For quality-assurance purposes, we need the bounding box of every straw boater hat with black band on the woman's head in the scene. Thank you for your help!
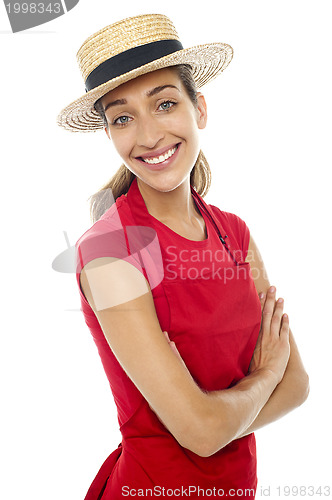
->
[57,14,233,132]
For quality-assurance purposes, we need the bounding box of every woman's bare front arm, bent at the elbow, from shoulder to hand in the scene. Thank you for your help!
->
[81,257,289,456]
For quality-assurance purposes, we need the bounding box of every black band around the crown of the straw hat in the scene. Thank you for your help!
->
[85,40,183,92]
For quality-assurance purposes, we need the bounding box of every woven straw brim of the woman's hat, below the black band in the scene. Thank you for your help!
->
[57,43,233,132]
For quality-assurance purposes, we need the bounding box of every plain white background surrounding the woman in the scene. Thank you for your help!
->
[0,0,332,500]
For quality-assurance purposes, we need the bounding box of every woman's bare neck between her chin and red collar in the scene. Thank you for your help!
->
[137,176,199,221]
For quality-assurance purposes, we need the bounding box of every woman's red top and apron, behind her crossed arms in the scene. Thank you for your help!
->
[76,179,261,500]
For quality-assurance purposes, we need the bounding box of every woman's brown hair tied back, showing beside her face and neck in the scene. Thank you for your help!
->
[89,64,211,223]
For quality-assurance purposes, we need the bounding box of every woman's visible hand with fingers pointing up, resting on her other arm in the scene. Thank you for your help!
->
[249,287,290,384]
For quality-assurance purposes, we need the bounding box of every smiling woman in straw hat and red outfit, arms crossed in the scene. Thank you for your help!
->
[58,15,308,500]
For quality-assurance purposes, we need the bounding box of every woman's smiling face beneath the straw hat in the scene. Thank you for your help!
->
[102,68,206,192]
